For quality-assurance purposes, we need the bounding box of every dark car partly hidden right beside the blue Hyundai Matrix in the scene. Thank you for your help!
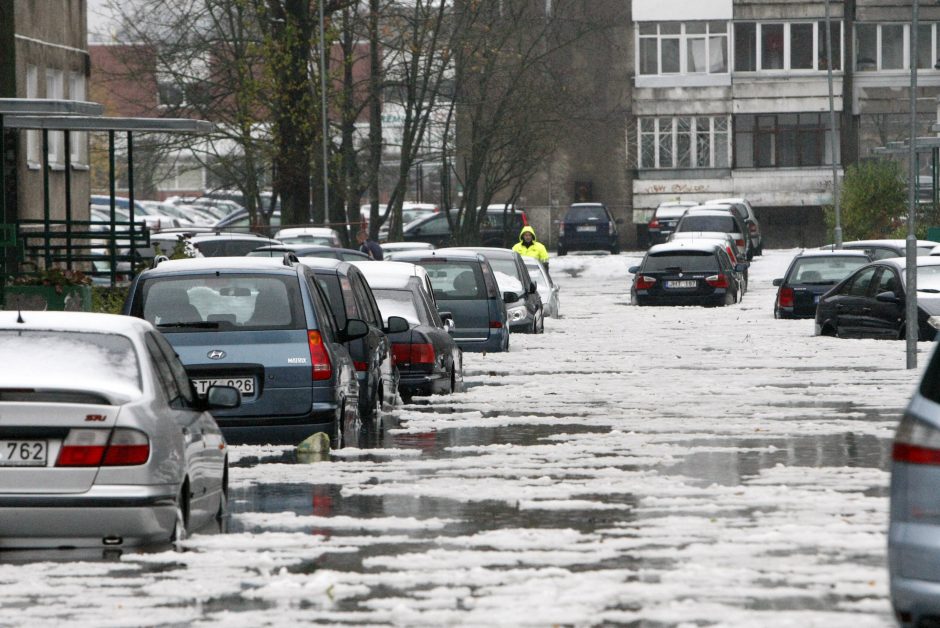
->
[300,257,408,421]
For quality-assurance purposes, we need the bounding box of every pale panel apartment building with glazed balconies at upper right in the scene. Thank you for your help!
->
[627,0,940,246]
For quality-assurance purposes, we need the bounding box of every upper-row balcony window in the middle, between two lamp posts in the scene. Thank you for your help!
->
[734,21,842,72]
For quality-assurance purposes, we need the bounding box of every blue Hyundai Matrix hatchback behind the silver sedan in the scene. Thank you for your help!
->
[124,257,369,446]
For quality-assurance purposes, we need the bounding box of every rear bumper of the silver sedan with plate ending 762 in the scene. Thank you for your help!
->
[0,485,178,549]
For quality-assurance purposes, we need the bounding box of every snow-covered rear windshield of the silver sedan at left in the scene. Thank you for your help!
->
[0,330,141,391]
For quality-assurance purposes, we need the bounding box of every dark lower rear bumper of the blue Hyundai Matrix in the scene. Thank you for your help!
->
[215,400,340,445]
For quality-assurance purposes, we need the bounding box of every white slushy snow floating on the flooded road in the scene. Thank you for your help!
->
[0,251,932,628]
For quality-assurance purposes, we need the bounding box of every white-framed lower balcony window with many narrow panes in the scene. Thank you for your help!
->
[639,116,730,168]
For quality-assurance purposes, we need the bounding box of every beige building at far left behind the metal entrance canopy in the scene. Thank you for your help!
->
[0,0,90,223]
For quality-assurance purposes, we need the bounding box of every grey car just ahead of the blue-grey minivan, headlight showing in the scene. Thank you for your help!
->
[444,247,545,334]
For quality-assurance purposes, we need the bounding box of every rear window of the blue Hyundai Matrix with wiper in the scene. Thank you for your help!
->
[133,273,306,333]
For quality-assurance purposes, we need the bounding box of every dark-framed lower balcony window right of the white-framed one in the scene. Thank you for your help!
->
[734,113,838,168]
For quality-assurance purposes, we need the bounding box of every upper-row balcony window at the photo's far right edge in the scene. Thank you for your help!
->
[855,22,937,72]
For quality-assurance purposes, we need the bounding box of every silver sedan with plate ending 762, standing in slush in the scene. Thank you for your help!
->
[0,312,239,549]
